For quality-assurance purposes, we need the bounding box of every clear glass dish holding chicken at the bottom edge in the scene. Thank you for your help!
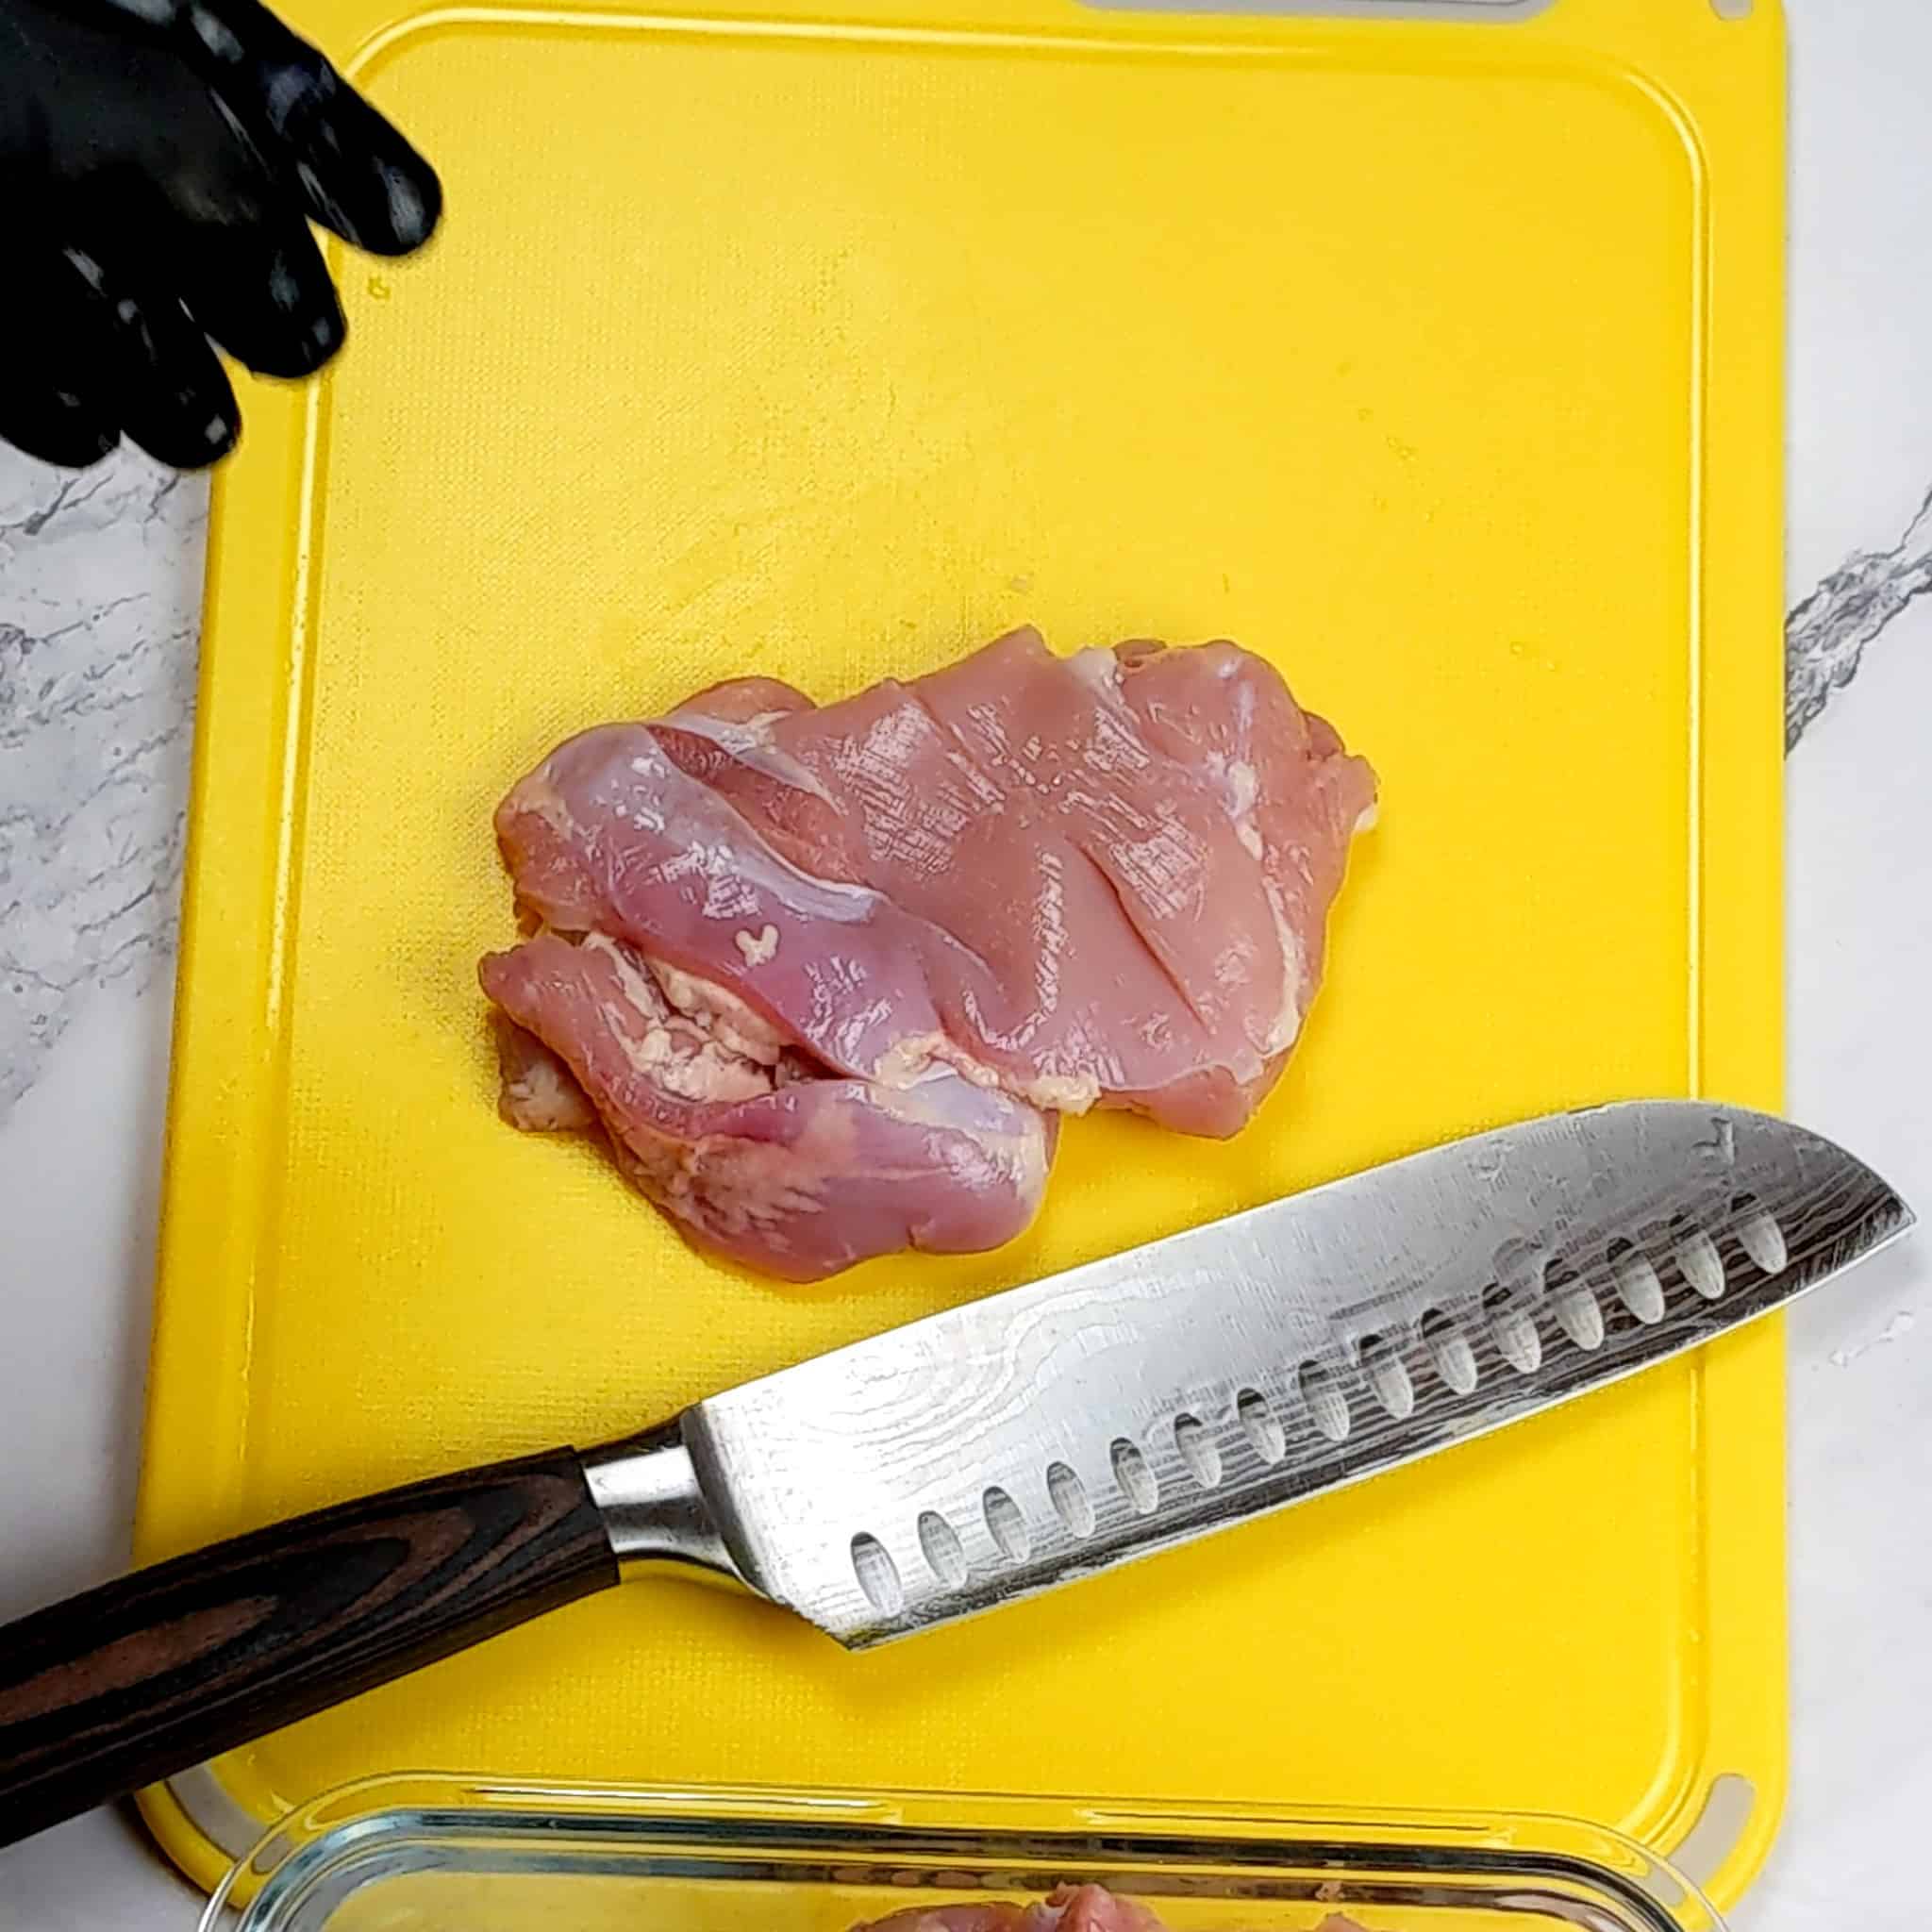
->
[203,1777,1724,1932]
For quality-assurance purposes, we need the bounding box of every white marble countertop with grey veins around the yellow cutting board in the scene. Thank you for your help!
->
[0,0,1932,1932]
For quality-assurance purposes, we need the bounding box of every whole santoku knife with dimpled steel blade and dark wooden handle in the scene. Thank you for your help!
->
[0,1101,1913,1843]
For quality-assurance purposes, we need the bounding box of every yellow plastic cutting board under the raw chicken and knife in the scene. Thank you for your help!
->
[139,0,1783,1893]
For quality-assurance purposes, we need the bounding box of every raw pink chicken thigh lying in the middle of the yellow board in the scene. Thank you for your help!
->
[481,630,1374,1281]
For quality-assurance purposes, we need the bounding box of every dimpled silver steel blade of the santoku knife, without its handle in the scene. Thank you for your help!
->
[657,1101,1910,1646]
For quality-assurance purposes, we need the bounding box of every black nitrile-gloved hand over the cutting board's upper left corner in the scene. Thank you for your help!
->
[0,0,442,470]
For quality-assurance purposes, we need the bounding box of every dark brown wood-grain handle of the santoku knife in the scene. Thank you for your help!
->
[0,1449,618,1845]
